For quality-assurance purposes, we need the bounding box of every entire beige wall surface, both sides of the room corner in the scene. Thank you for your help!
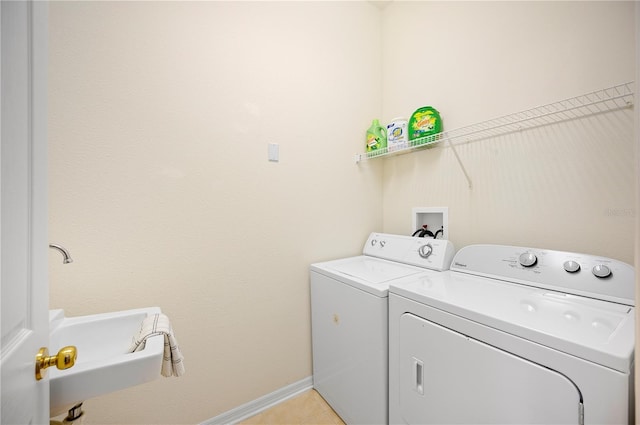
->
[49,2,636,423]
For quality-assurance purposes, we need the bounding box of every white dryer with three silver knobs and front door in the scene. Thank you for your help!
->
[389,245,635,424]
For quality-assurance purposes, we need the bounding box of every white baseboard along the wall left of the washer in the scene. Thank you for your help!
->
[200,376,313,425]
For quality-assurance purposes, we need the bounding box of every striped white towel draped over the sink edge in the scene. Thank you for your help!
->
[129,313,184,377]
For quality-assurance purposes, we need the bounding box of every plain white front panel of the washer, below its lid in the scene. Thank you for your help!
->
[310,272,388,424]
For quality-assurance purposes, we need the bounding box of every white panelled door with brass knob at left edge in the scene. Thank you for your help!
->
[0,1,49,425]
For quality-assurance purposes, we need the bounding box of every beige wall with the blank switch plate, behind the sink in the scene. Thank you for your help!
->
[49,1,382,424]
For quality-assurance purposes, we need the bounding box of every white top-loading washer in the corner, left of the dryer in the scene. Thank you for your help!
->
[310,233,454,425]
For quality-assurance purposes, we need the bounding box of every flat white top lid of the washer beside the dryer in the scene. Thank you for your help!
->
[311,255,425,297]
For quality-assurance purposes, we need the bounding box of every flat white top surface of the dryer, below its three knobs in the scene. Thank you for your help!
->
[389,272,635,373]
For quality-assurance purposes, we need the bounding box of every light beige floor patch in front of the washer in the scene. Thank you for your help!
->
[239,390,345,425]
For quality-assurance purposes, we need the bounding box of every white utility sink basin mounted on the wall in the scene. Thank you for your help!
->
[47,307,164,416]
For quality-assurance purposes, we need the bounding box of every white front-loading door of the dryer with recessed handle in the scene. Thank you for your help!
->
[398,313,582,424]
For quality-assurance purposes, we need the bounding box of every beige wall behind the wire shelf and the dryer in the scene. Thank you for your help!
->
[383,2,636,263]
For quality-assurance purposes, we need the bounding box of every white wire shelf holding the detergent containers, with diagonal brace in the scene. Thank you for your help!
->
[355,81,634,187]
